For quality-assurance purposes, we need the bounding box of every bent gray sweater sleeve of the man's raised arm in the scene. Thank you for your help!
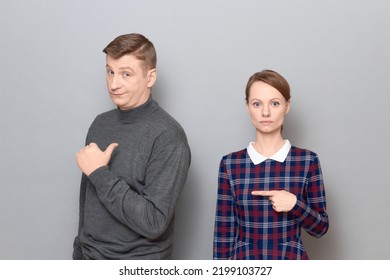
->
[89,140,191,239]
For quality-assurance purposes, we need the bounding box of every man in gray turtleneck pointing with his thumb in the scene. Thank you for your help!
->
[73,33,191,259]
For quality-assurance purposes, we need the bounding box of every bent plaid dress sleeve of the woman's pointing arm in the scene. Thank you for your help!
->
[292,156,329,237]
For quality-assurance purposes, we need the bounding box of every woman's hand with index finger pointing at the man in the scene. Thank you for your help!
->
[252,190,297,212]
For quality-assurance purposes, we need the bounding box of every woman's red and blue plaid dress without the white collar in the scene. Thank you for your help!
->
[213,146,329,260]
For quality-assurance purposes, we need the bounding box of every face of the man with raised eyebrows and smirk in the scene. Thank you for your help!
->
[106,55,156,110]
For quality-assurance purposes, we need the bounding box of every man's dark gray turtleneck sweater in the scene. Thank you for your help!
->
[73,98,191,259]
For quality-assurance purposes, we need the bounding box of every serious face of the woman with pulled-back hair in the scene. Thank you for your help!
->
[247,81,290,134]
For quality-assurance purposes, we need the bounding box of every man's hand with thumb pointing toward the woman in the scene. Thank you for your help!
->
[76,143,118,176]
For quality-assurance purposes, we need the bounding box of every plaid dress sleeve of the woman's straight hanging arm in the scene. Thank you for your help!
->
[213,159,237,260]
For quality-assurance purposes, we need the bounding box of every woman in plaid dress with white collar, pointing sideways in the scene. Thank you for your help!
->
[214,70,328,260]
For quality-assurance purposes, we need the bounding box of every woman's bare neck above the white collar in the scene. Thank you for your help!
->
[253,133,285,157]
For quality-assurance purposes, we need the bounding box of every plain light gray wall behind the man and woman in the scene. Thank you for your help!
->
[0,0,390,260]
